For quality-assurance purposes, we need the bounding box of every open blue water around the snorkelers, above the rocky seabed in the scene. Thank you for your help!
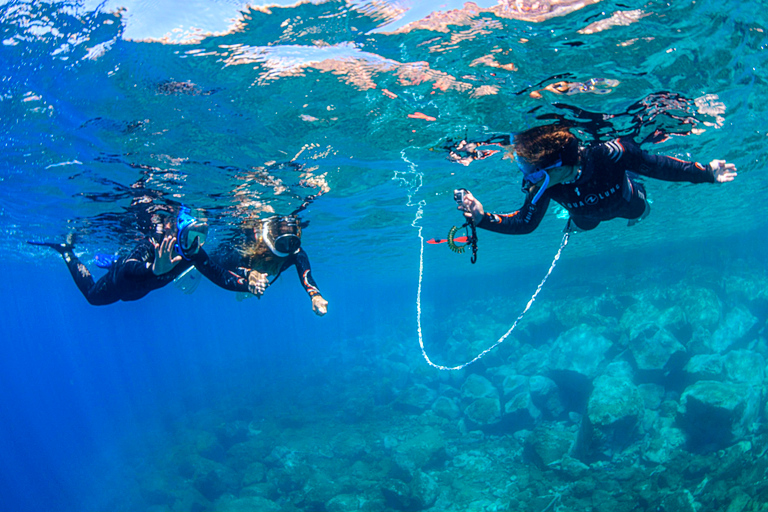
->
[0,0,768,510]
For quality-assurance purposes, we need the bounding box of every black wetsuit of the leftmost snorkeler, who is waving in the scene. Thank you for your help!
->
[62,239,248,306]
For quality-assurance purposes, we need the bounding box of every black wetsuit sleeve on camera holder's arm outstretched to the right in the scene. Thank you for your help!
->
[600,139,715,183]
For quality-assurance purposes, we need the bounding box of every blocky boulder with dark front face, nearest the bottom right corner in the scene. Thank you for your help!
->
[680,380,761,452]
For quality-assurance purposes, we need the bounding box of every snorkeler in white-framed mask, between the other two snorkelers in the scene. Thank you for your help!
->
[214,215,328,316]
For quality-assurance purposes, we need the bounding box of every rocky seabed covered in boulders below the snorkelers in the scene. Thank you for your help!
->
[129,269,768,512]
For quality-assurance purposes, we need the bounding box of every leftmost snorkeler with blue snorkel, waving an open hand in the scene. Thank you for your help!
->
[28,208,266,306]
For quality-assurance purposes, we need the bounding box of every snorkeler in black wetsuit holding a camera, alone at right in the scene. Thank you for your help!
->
[459,125,736,234]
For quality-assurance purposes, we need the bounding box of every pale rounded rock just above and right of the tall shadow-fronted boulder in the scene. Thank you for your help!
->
[629,323,685,372]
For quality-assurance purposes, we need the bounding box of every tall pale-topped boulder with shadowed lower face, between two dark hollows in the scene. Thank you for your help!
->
[582,375,644,457]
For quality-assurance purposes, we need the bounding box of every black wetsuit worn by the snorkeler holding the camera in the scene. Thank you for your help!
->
[477,139,715,234]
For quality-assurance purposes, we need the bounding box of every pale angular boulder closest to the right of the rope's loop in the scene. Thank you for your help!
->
[548,324,612,379]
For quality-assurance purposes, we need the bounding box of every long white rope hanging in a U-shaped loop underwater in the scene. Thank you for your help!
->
[402,150,570,370]
